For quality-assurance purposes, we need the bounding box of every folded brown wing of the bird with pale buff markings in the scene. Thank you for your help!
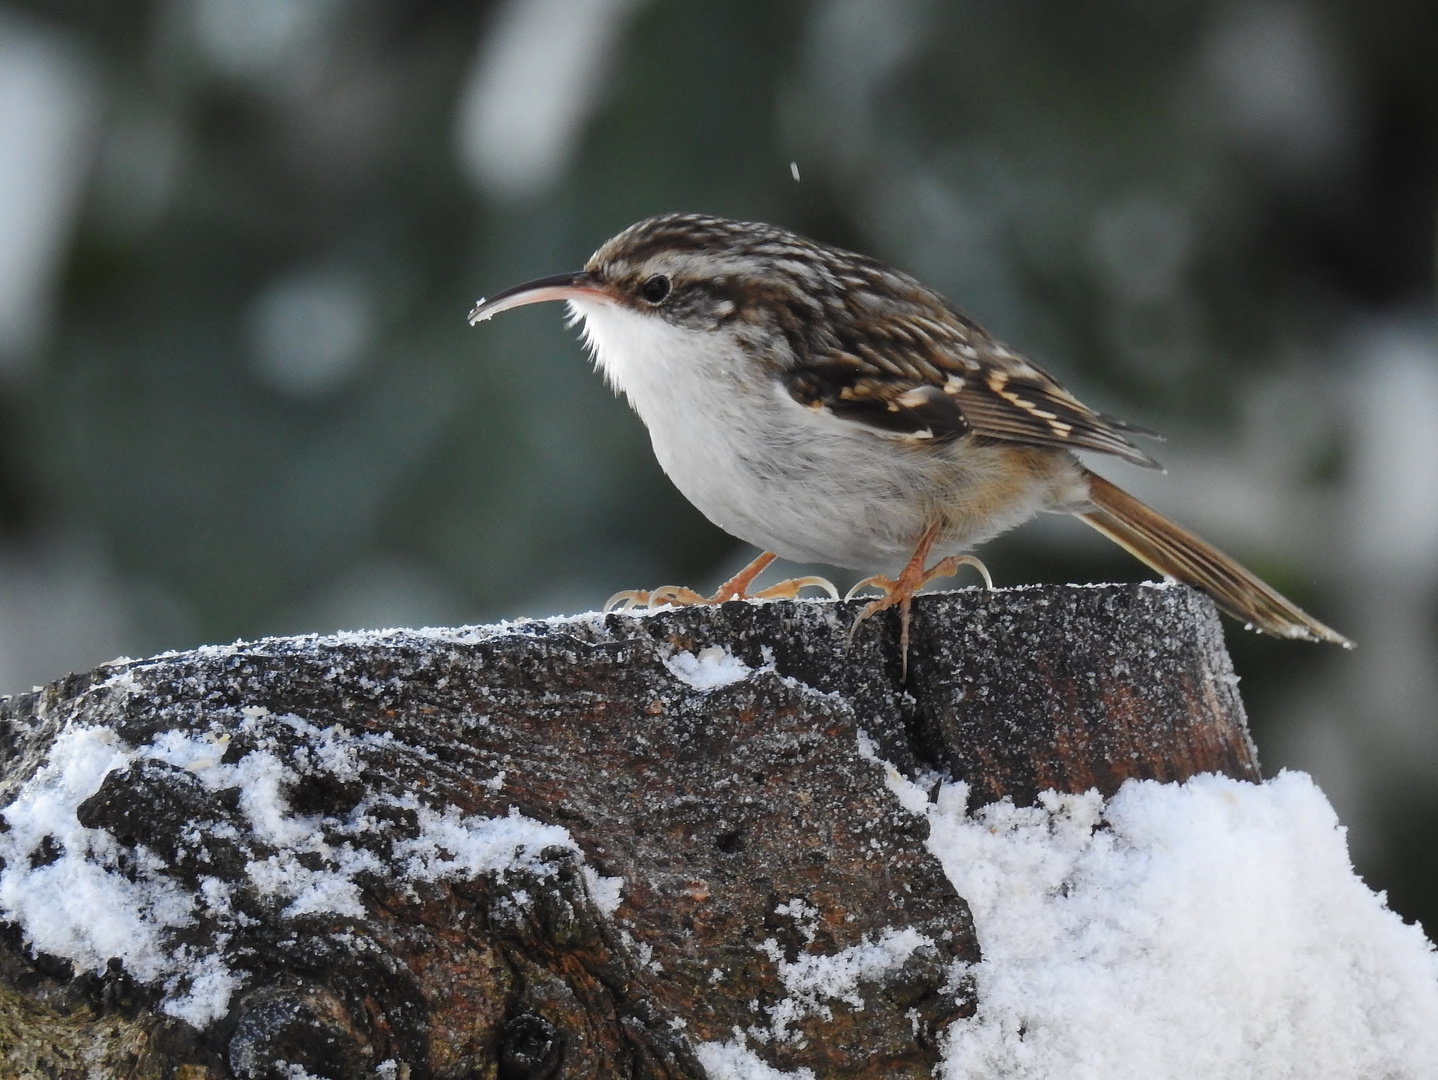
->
[781,309,1159,469]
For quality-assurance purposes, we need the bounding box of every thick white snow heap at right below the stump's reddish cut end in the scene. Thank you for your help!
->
[910,772,1438,1080]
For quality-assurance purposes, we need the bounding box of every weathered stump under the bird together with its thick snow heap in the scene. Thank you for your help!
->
[0,585,1438,1080]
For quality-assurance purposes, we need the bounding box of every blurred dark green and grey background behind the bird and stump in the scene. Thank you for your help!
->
[0,0,1438,928]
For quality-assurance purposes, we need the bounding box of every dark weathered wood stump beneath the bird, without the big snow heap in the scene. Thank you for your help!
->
[0,584,1258,1080]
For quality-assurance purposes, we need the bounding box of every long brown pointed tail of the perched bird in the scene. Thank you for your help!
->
[1079,470,1353,649]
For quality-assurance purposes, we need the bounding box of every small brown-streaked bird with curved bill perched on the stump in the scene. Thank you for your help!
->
[469,213,1352,655]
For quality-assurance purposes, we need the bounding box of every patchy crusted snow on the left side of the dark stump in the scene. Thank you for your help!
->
[0,713,609,1028]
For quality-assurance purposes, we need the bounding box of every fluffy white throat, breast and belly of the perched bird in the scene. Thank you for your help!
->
[569,301,1064,571]
